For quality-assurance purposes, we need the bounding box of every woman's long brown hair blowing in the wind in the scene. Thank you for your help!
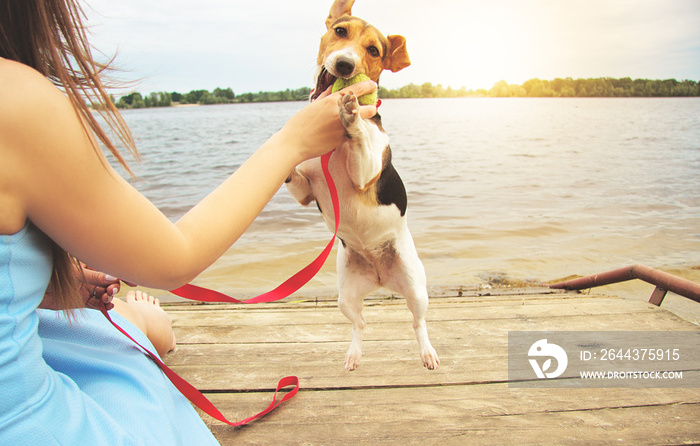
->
[0,0,138,309]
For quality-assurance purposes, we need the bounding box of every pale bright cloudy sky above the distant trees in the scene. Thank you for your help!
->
[83,0,700,94]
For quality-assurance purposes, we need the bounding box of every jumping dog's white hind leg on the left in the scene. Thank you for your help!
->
[338,244,379,372]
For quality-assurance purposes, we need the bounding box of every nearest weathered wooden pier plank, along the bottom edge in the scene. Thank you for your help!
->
[194,384,700,445]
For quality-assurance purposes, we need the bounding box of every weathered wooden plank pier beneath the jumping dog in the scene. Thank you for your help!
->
[165,288,700,446]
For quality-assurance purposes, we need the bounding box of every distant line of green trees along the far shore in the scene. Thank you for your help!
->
[115,77,700,108]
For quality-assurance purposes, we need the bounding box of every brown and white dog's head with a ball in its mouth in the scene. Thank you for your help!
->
[314,0,411,101]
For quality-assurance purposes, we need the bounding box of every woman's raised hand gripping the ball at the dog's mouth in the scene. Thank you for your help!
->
[278,81,377,162]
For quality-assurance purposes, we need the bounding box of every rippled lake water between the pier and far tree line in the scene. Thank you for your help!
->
[116,98,700,320]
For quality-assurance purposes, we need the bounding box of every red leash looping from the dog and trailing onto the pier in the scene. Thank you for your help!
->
[102,151,340,426]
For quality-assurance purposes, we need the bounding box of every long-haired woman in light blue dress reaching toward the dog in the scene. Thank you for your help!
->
[0,0,376,445]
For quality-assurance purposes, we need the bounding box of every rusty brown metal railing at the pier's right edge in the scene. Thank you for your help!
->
[550,265,700,306]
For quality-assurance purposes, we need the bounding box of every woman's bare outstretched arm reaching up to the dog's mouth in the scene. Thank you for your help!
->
[0,59,376,289]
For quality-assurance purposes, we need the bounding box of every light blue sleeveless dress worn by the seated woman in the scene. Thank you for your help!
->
[0,223,218,446]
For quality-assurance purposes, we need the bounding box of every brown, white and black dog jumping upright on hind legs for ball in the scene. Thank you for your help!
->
[286,0,440,371]
